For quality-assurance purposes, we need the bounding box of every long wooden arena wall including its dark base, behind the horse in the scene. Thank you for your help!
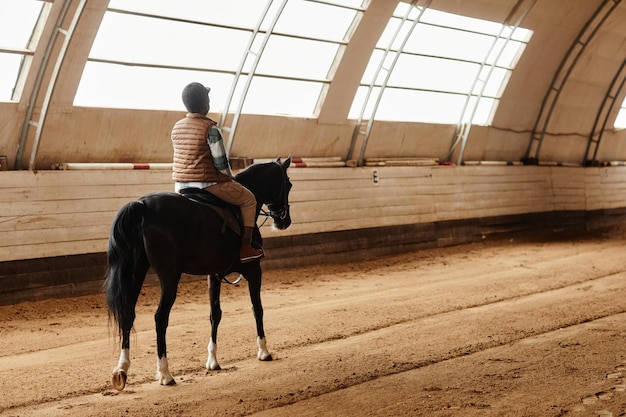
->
[0,166,626,304]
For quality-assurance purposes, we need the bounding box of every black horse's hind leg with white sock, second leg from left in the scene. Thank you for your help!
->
[154,271,181,385]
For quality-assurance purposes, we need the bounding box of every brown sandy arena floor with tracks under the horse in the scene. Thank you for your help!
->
[0,234,626,417]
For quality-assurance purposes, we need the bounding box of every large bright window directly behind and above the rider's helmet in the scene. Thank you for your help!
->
[74,0,361,117]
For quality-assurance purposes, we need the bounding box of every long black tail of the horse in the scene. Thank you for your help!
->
[104,201,146,336]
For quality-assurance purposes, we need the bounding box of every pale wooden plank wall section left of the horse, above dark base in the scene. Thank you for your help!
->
[0,171,173,260]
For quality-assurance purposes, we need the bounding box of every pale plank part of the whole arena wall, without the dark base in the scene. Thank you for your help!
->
[0,166,626,262]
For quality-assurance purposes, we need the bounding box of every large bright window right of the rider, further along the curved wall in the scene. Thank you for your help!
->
[350,2,531,124]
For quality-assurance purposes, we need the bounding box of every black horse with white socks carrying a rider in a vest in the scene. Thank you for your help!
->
[104,157,292,391]
